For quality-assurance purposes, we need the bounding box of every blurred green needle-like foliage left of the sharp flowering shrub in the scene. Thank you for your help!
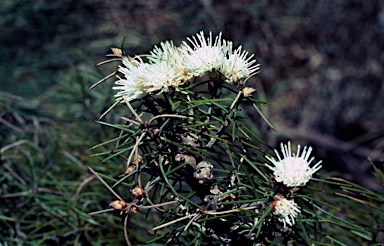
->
[0,64,127,245]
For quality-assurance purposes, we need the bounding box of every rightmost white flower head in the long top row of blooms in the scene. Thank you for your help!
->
[220,42,260,82]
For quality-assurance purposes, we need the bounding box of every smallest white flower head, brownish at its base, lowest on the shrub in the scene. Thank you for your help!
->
[272,195,300,228]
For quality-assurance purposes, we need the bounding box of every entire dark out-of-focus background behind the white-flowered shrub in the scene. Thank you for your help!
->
[0,0,384,245]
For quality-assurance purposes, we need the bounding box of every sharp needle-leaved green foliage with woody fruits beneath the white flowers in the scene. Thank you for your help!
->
[88,46,383,245]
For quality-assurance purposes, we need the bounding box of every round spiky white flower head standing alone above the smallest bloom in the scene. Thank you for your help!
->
[266,142,321,187]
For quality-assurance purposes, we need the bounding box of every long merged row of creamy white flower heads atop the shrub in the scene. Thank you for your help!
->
[113,32,259,101]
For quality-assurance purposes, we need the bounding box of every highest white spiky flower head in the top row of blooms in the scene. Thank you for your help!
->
[182,31,228,77]
